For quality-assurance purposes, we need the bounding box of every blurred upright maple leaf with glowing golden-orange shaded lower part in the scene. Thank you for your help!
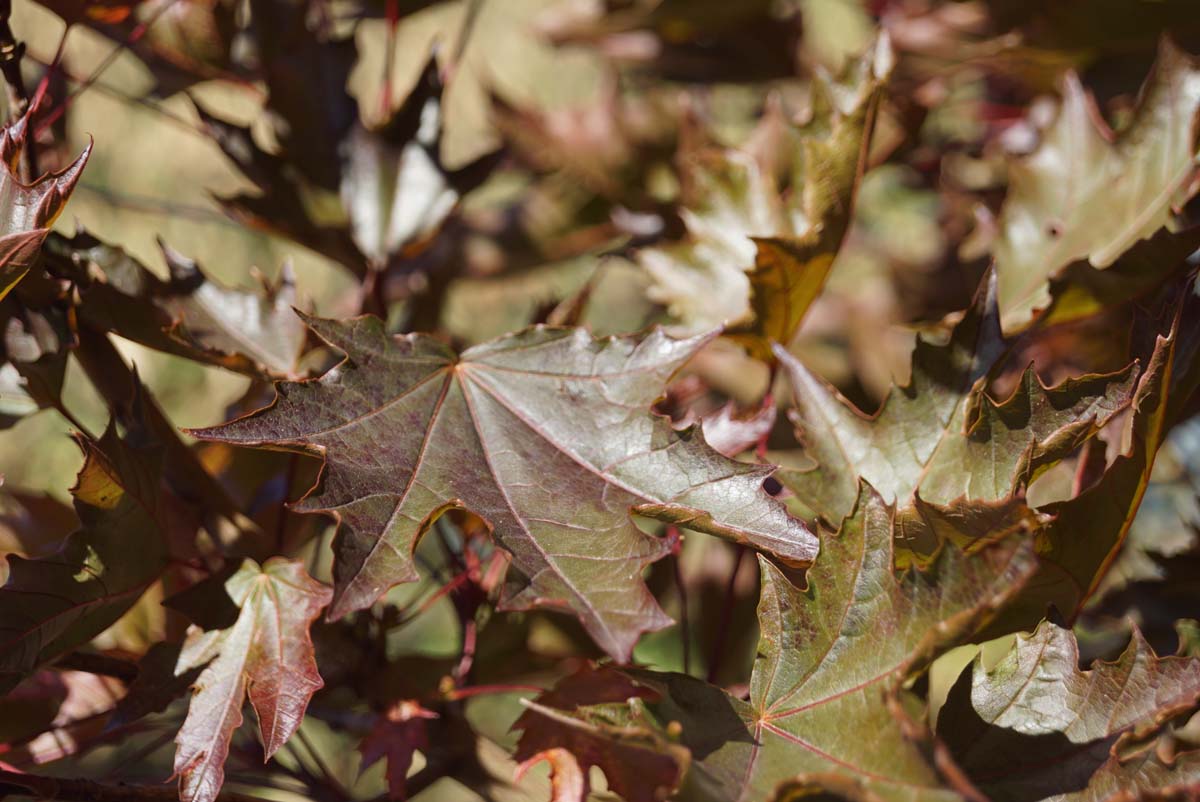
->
[638,36,893,359]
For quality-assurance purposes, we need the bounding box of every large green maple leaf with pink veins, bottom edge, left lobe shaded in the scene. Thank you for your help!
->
[525,485,1036,801]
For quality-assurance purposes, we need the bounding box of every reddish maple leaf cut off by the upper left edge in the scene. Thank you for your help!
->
[0,115,91,299]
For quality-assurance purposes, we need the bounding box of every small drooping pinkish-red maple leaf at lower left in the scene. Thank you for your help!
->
[175,557,332,802]
